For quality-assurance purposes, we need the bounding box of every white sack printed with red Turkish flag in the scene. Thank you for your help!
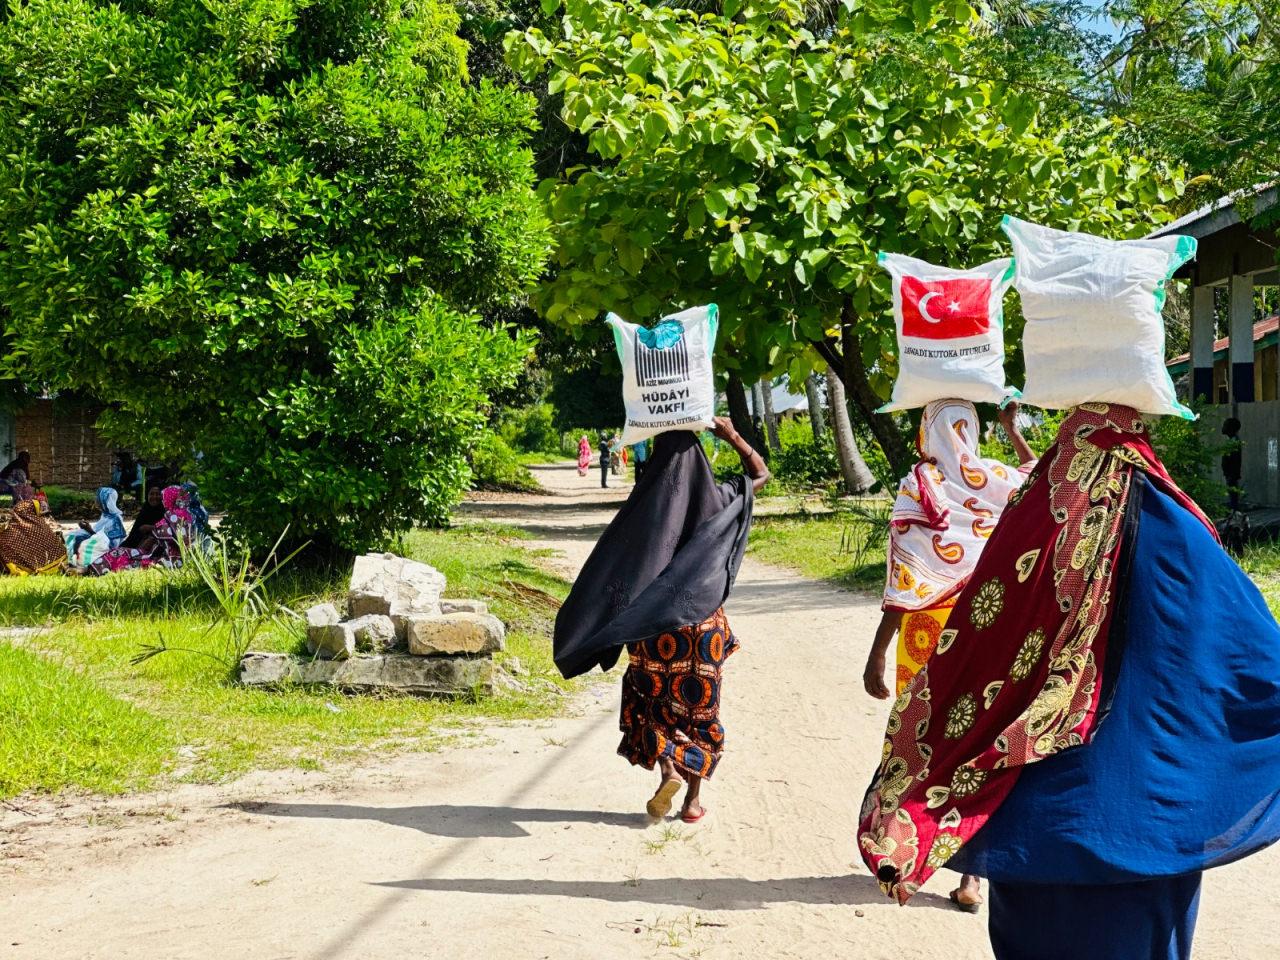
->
[879,253,1018,412]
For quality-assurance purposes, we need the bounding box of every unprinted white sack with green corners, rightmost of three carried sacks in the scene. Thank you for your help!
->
[1004,216,1196,420]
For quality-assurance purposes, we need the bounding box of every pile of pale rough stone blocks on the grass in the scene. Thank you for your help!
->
[241,553,507,695]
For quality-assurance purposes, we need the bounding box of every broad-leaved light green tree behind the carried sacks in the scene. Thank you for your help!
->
[507,0,1178,471]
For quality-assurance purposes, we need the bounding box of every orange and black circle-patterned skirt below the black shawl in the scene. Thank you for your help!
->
[618,608,739,778]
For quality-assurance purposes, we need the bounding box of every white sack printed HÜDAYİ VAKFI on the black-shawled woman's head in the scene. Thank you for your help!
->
[608,303,719,444]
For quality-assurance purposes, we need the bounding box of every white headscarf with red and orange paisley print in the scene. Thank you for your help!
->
[883,399,1034,612]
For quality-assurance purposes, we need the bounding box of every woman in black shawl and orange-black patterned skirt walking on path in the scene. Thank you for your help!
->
[556,417,769,823]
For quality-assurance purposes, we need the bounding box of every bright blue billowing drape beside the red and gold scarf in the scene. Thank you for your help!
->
[948,477,1280,883]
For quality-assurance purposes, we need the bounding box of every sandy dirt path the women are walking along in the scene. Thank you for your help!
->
[0,467,1280,960]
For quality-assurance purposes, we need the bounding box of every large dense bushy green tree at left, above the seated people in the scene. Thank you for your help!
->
[0,0,548,548]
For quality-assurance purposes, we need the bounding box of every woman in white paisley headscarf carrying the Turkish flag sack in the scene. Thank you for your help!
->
[863,399,1036,913]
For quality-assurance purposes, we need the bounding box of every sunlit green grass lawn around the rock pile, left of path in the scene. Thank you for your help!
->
[0,525,571,797]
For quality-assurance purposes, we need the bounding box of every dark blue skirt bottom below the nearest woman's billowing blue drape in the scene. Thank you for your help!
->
[988,873,1201,960]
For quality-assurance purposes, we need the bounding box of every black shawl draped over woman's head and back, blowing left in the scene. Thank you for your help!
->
[554,430,754,677]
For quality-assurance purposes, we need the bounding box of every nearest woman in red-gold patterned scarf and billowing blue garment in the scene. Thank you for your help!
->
[859,403,1280,960]
